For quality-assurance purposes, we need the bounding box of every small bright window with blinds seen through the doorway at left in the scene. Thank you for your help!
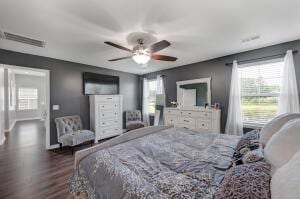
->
[18,88,38,110]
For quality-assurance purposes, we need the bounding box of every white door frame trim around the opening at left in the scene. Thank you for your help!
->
[0,64,51,150]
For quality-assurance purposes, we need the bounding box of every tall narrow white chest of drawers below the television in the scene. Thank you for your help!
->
[90,95,123,143]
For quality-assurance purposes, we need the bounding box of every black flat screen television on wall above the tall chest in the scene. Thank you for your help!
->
[83,72,119,95]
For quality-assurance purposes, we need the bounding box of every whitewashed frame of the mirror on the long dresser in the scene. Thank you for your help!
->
[176,77,211,108]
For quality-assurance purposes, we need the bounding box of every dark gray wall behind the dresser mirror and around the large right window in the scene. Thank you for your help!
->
[144,40,300,131]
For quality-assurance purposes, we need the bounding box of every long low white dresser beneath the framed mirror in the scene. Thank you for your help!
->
[164,108,221,133]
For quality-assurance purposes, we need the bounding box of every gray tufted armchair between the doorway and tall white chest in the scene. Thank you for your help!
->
[55,115,95,154]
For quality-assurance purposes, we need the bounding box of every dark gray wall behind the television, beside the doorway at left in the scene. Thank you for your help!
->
[0,49,141,144]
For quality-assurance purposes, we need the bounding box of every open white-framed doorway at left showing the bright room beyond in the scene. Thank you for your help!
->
[0,65,51,149]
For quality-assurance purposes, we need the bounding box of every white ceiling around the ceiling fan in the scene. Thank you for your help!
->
[0,0,300,74]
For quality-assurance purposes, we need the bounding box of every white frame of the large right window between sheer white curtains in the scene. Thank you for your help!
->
[238,58,284,129]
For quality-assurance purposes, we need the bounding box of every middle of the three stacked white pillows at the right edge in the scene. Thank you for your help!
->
[264,119,300,174]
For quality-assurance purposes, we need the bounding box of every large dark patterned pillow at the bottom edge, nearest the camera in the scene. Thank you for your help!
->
[214,162,271,199]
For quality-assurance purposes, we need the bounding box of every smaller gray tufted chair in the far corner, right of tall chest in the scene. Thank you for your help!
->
[126,110,146,131]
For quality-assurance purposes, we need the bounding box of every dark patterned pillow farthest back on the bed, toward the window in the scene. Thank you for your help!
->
[234,130,260,161]
